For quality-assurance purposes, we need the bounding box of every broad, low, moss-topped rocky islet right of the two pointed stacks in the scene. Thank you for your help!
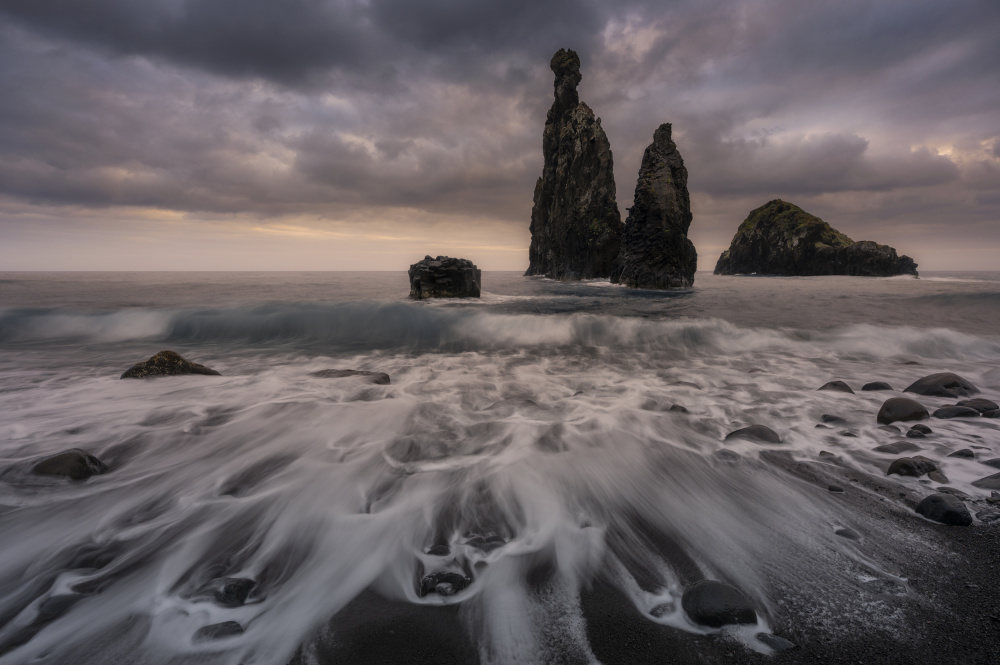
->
[715,199,917,277]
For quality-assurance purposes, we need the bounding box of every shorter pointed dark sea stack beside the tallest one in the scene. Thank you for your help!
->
[611,123,698,289]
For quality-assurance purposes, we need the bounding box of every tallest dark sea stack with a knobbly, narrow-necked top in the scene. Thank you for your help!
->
[524,49,622,280]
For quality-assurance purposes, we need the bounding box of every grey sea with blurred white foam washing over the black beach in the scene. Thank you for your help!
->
[0,271,1000,665]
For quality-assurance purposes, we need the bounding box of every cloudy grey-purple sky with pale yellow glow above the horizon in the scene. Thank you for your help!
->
[0,0,1000,270]
